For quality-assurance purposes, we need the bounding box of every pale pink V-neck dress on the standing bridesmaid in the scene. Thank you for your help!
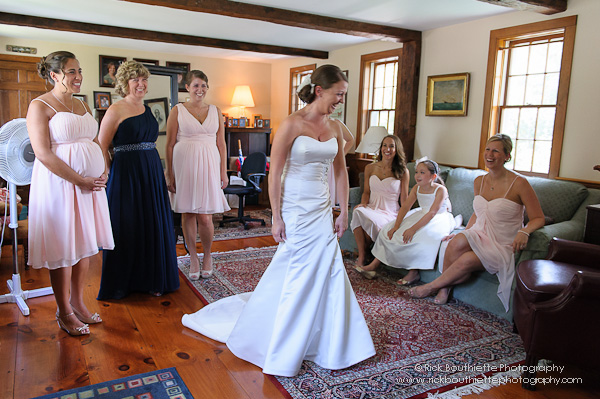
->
[170,104,231,214]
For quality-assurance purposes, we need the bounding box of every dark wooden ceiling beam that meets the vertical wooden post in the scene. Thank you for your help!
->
[121,0,421,43]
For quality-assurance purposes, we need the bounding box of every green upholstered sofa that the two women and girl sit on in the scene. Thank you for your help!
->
[340,162,600,320]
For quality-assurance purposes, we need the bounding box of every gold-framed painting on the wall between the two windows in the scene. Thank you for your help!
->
[425,72,470,116]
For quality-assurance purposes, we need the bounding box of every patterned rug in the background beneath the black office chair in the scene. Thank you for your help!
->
[177,209,271,244]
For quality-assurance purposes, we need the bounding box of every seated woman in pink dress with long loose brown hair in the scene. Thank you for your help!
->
[350,135,410,266]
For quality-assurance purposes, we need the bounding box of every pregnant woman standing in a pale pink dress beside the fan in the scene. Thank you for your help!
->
[27,51,114,335]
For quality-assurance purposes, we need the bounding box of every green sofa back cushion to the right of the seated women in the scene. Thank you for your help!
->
[526,177,588,223]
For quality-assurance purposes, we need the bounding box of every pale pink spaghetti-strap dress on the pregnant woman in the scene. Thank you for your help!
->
[27,99,114,269]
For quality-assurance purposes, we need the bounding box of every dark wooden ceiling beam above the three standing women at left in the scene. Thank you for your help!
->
[0,12,329,59]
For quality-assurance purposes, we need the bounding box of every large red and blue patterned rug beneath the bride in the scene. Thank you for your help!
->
[179,247,525,399]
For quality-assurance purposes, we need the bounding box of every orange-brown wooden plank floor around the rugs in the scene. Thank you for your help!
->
[0,237,600,399]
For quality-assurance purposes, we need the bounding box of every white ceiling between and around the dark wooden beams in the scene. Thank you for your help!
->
[0,0,514,62]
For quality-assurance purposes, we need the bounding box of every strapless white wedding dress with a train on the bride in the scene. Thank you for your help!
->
[182,136,375,377]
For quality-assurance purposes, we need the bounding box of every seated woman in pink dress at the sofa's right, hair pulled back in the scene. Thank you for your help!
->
[409,134,544,312]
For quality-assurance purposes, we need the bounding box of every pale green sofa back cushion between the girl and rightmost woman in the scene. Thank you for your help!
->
[446,168,486,226]
